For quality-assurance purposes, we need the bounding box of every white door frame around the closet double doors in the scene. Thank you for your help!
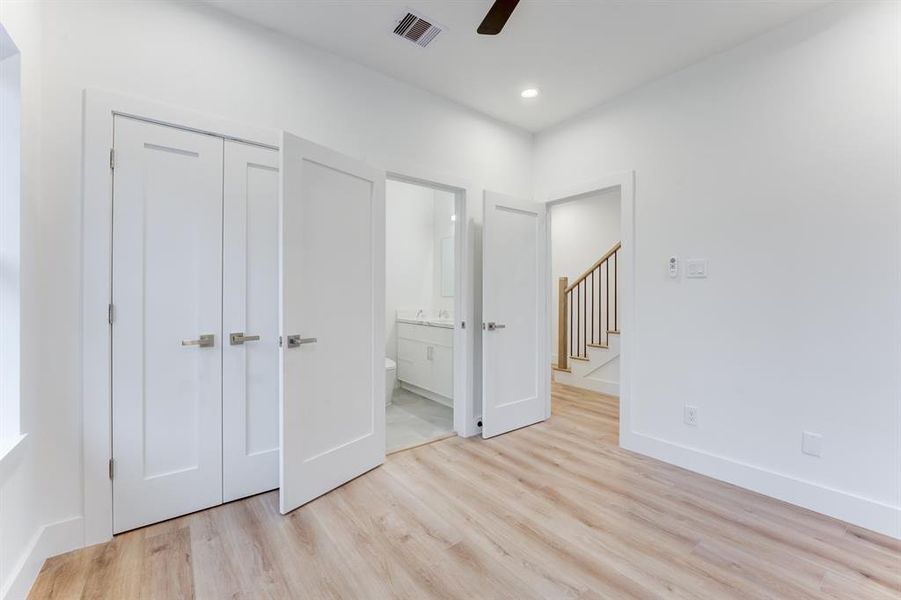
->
[81,89,280,546]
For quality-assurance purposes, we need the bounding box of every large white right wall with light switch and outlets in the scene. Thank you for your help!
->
[535,2,901,536]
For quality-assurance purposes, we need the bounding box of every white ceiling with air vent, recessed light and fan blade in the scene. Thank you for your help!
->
[209,0,825,131]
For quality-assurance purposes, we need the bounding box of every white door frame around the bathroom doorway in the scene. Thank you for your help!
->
[385,166,482,437]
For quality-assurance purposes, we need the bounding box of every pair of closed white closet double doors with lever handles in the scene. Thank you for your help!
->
[110,116,280,533]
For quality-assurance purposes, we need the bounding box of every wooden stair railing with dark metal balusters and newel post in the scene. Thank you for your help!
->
[557,242,622,371]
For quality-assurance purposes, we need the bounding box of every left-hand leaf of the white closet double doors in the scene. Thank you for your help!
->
[112,116,223,532]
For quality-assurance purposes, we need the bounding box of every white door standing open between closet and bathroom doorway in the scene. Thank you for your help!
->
[280,133,385,513]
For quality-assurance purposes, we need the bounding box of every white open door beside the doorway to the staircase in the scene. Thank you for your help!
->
[482,192,550,438]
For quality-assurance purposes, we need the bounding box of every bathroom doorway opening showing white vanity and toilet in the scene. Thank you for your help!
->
[385,179,462,452]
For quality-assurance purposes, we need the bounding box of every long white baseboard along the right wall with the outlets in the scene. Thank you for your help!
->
[620,431,901,539]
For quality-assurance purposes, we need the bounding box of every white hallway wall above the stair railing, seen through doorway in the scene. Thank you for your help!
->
[550,188,620,362]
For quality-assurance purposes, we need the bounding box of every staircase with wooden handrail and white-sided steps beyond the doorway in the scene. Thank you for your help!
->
[553,243,621,396]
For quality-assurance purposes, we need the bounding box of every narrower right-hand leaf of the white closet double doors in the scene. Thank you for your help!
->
[222,141,279,502]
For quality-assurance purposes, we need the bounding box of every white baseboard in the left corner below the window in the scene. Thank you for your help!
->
[0,517,84,600]
